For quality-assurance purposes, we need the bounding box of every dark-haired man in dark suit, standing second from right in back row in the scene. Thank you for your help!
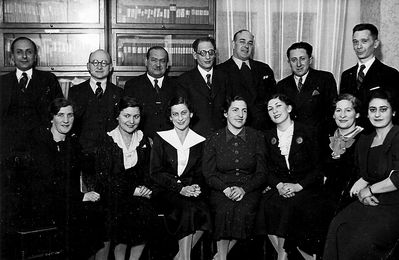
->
[277,42,337,136]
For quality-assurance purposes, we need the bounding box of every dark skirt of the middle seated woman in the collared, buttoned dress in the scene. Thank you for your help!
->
[210,191,260,240]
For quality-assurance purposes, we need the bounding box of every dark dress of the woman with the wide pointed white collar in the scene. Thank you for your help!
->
[150,129,211,239]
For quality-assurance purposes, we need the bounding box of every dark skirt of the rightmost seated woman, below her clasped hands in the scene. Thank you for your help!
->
[323,197,399,260]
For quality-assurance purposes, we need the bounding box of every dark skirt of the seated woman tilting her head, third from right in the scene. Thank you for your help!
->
[256,189,332,254]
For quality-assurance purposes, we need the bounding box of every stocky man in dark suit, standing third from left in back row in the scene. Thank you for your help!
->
[123,46,176,138]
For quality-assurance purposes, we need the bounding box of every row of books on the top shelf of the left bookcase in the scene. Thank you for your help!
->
[4,0,99,23]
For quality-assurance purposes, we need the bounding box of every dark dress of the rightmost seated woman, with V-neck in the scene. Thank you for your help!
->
[323,126,399,260]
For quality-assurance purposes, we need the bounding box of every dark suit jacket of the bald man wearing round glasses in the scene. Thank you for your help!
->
[69,79,122,152]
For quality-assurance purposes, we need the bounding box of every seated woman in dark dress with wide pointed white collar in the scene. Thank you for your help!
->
[150,97,211,260]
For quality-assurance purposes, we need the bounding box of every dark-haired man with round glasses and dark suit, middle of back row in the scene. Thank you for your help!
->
[177,37,229,137]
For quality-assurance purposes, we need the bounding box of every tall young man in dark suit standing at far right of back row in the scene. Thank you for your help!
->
[340,24,399,131]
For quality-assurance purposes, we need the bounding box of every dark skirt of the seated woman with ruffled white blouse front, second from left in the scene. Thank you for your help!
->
[110,196,158,246]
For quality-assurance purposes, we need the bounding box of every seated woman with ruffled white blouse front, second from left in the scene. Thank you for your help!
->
[98,96,157,260]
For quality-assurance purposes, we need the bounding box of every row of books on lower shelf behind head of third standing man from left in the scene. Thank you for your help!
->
[117,43,195,67]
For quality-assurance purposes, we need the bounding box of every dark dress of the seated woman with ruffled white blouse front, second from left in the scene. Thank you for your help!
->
[99,131,157,246]
